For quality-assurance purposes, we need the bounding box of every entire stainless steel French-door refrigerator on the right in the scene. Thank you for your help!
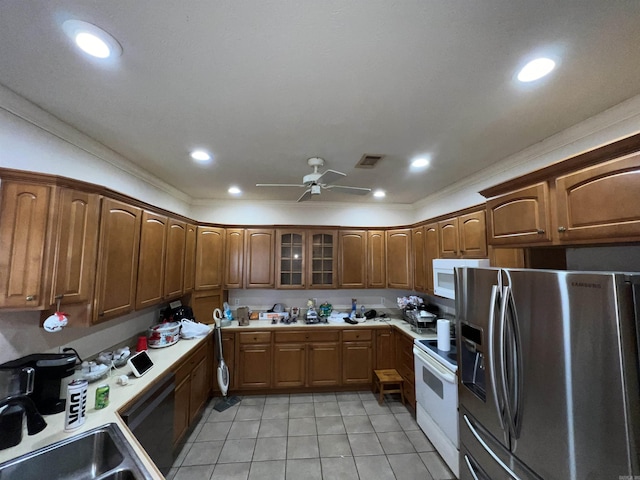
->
[456,268,640,480]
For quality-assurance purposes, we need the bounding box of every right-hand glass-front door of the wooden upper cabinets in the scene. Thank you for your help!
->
[307,230,338,288]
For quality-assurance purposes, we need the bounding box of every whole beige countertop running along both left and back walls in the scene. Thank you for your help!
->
[0,318,436,479]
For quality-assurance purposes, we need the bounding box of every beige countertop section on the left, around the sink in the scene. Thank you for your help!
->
[0,337,211,479]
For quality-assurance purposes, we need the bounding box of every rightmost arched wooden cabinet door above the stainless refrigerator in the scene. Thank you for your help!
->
[554,152,640,243]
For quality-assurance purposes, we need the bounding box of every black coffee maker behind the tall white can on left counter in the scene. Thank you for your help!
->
[0,353,77,415]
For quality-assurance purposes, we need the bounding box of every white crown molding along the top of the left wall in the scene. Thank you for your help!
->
[0,84,192,204]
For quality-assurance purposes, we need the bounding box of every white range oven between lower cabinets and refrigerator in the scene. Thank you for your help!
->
[413,339,460,477]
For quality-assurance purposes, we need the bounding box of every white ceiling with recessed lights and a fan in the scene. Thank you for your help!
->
[0,0,640,204]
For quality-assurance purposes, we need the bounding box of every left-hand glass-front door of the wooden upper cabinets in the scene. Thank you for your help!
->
[276,230,306,289]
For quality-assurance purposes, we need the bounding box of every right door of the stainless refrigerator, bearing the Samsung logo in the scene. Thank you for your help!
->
[504,270,637,480]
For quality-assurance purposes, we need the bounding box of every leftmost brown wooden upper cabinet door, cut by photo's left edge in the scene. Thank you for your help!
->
[0,180,52,309]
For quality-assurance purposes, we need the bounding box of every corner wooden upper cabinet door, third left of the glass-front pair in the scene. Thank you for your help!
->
[195,227,225,290]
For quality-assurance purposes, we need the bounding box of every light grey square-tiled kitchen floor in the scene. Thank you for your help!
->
[167,392,455,480]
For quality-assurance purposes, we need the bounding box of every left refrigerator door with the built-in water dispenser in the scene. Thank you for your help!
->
[456,268,509,448]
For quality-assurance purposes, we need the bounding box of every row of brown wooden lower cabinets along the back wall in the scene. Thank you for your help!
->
[225,327,415,408]
